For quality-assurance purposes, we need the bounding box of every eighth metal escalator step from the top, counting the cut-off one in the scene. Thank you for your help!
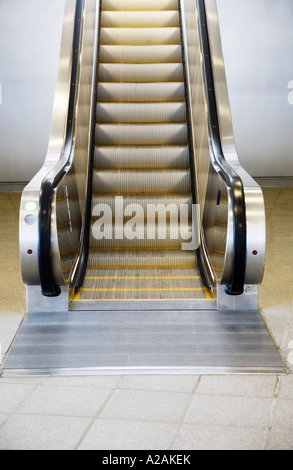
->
[96,124,188,146]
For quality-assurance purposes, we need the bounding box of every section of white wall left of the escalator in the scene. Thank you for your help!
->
[0,0,64,182]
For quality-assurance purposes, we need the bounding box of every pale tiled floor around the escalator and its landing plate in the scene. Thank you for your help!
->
[0,189,293,450]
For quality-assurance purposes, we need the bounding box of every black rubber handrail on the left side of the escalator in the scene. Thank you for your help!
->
[38,0,84,297]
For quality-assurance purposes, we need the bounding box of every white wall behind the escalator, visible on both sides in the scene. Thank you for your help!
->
[0,0,293,182]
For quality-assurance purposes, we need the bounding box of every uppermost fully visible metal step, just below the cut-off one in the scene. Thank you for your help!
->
[101,9,179,28]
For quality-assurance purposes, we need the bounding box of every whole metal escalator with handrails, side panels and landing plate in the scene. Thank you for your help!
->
[4,0,283,372]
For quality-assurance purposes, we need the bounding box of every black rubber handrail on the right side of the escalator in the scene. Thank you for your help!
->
[197,0,247,295]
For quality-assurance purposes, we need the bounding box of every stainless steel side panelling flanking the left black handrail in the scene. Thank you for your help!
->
[20,0,99,294]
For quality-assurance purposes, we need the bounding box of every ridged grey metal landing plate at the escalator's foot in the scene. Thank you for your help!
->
[2,310,285,375]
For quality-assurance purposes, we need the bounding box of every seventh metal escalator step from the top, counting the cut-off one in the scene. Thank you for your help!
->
[96,102,186,124]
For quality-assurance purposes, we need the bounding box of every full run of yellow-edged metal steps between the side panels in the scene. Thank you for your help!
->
[75,1,206,301]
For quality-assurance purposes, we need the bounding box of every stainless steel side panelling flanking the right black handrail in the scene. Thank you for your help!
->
[181,0,266,285]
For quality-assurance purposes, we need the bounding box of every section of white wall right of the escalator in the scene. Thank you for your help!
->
[217,0,293,177]
